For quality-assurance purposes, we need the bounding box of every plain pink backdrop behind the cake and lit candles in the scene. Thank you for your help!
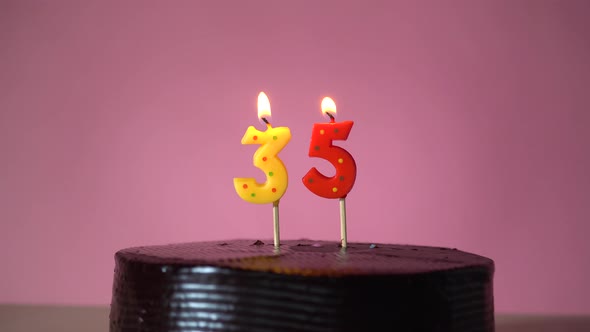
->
[0,0,590,314]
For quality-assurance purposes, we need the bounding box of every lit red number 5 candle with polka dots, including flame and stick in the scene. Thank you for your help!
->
[303,97,356,248]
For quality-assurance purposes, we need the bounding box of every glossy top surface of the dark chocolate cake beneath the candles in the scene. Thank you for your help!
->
[116,239,494,276]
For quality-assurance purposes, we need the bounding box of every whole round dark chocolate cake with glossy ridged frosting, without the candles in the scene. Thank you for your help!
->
[110,240,494,332]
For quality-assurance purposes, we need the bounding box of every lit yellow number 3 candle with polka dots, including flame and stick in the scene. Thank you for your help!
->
[234,92,291,247]
